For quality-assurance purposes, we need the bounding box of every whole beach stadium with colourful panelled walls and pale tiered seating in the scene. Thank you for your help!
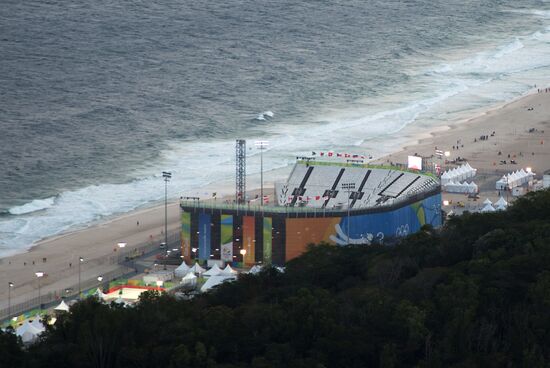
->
[180,159,442,266]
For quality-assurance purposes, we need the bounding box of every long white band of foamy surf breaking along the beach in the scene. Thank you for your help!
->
[0,17,550,255]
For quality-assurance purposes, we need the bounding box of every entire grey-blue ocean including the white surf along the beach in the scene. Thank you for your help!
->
[0,0,550,256]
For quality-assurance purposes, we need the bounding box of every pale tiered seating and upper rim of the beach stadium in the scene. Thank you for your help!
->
[180,159,441,217]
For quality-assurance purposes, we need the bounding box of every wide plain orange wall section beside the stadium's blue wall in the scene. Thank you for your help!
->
[285,217,340,261]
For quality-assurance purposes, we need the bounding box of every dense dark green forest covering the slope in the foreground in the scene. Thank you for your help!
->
[0,191,550,368]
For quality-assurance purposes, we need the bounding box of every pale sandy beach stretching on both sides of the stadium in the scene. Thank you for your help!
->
[0,91,550,314]
